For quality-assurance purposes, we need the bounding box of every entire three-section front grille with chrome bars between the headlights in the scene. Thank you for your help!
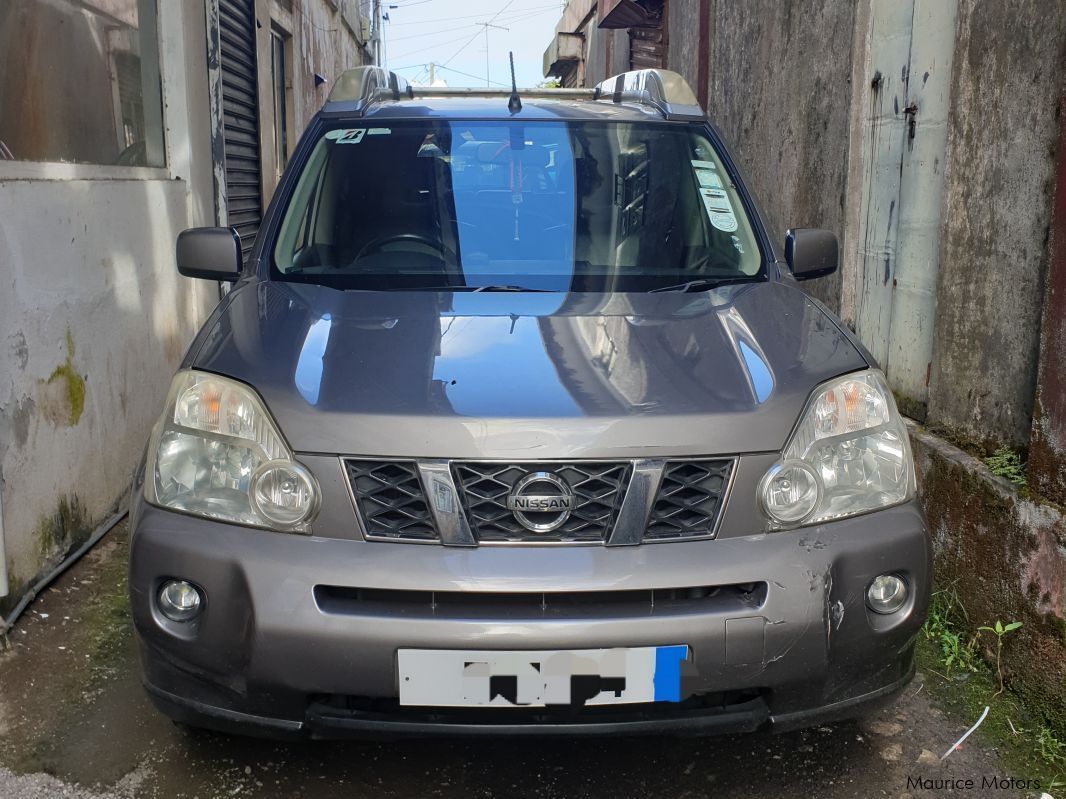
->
[343,458,736,545]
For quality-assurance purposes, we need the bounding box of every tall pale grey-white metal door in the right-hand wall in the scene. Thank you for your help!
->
[855,0,957,417]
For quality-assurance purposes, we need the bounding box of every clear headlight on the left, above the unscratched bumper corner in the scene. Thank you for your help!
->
[145,371,319,532]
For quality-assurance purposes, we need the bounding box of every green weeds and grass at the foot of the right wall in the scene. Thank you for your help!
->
[917,586,1066,795]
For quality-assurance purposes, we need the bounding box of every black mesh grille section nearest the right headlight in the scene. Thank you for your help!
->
[644,460,733,541]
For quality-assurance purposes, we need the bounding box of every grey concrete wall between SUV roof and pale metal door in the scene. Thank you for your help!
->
[707,0,856,310]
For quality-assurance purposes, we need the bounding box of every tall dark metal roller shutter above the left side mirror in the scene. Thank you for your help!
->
[219,0,262,258]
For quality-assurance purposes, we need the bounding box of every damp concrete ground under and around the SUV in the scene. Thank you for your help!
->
[0,523,1039,799]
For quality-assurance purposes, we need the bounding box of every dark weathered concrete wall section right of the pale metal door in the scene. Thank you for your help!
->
[928,0,1066,445]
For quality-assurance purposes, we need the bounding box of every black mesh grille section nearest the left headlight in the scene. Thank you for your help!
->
[344,460,438,541]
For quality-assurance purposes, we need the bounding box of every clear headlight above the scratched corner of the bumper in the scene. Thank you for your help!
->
[759,370,915,527]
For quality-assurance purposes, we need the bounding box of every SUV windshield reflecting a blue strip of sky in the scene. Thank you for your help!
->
[272,119,764,291]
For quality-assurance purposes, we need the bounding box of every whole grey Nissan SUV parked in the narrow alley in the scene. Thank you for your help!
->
[129,68,930,737]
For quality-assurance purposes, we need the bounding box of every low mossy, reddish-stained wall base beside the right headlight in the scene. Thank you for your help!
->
[911,428,1066,723]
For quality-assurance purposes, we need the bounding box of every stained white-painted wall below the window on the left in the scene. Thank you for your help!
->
[0,3,217,610]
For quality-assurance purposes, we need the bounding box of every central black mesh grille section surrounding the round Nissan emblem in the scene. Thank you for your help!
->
[452,461,630,543]
